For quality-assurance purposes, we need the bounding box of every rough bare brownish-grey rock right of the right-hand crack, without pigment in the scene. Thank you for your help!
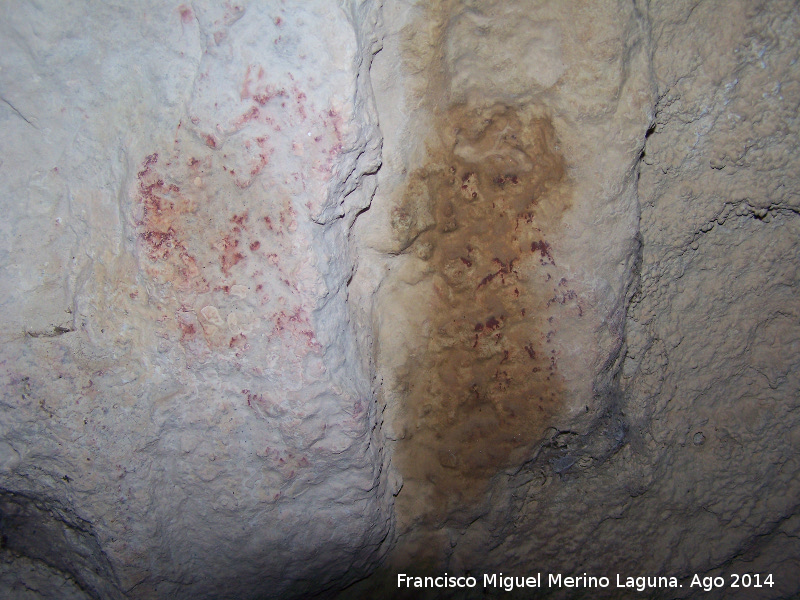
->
[622,2,800,598]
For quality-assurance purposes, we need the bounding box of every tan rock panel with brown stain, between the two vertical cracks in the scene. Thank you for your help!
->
[352,2,653,569]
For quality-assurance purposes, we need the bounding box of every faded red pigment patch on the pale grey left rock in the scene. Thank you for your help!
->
[131,52,348,366]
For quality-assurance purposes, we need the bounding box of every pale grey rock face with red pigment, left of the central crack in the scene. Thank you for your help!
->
[0,1,389,598]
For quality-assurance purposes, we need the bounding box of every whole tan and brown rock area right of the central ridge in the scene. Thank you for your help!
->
[346,1,800,598]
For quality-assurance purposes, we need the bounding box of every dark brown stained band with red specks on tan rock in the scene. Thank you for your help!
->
[392,105,569,524]
